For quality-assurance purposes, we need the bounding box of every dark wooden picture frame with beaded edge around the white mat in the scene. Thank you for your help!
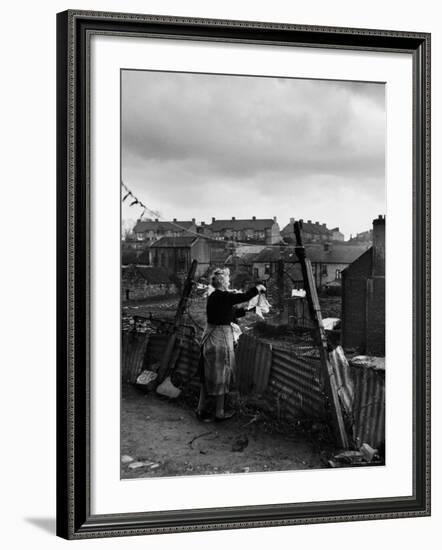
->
[57,10,430,539]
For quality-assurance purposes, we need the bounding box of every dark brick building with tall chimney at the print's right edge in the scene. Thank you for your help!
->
[342,216,385,356]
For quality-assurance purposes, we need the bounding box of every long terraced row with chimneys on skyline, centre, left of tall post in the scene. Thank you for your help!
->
[198,216,281,244]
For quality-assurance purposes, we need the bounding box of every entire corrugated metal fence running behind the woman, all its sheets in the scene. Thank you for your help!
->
[122,330,385,448]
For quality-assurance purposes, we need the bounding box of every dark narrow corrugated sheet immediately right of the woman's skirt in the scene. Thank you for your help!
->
[235,334,272,395]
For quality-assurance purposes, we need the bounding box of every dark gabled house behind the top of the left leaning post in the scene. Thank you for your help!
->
[149,235,210,279]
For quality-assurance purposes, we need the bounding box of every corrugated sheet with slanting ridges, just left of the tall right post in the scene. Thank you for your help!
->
[268,346,325,418]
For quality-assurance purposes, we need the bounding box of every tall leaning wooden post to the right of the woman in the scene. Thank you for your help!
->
[294,222,349,449]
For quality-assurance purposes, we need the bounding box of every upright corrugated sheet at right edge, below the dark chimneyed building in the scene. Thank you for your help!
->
[351,365,385,448]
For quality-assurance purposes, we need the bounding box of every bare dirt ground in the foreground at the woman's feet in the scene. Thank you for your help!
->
[121,385,328,479]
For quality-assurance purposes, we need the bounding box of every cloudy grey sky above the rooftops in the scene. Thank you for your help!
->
[122,70,385,238]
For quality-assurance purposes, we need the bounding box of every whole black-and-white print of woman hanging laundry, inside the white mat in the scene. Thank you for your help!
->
[120,69,388,480]
